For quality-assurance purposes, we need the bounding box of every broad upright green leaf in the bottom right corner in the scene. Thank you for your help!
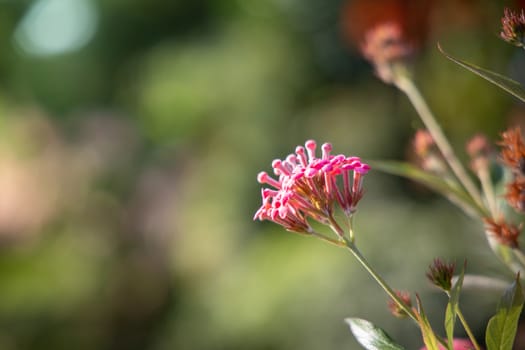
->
[485,273,524,350]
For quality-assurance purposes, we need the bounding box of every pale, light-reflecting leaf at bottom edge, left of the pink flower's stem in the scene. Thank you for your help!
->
[345,318,403,350]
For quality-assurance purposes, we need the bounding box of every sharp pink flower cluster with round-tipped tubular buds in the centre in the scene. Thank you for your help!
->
[254,140,370,233]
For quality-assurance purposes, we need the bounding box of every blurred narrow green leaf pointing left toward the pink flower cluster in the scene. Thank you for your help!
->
[369,161,488,217]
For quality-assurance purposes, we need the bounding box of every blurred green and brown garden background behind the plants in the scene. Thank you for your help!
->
[0,0,525,350]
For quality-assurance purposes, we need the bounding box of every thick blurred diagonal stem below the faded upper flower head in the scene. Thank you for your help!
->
[394,74,484,212]
